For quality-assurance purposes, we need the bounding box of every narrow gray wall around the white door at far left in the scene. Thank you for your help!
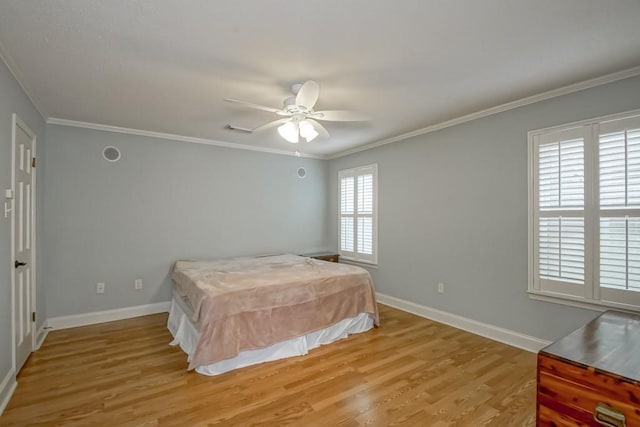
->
[0,59,45,388]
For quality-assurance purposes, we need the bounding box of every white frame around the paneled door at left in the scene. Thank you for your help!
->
[10,113,38,375]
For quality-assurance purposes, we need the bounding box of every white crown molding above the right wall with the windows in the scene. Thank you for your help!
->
[326,66,640,159]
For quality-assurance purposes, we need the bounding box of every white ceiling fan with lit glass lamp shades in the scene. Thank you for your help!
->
[224,80,369,143]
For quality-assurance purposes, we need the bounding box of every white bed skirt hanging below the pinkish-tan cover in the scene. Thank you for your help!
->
[167,294,373,375]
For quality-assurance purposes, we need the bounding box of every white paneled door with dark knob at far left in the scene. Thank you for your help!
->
[11,114,35,372]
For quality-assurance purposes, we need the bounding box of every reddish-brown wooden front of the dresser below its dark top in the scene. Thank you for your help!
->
[538,355,640,426]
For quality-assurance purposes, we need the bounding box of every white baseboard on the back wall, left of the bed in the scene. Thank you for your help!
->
[47,301,171,329]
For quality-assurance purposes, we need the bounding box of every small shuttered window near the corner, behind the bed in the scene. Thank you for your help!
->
[338,165,378,264]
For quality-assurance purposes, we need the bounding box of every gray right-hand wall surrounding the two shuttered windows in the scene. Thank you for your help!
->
[329,77,640,340]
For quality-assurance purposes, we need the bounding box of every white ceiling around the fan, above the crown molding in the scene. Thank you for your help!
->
[0,0,640,155]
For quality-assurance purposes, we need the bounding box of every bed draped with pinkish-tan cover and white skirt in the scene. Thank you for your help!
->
[167,254,379,375]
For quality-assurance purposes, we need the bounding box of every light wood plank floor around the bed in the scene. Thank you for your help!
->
[0,305,536,427]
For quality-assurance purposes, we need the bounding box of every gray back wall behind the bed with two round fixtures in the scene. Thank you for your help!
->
[45,125,330,317]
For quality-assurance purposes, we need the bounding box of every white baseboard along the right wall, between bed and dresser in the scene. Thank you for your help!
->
[376,292,551,353]
